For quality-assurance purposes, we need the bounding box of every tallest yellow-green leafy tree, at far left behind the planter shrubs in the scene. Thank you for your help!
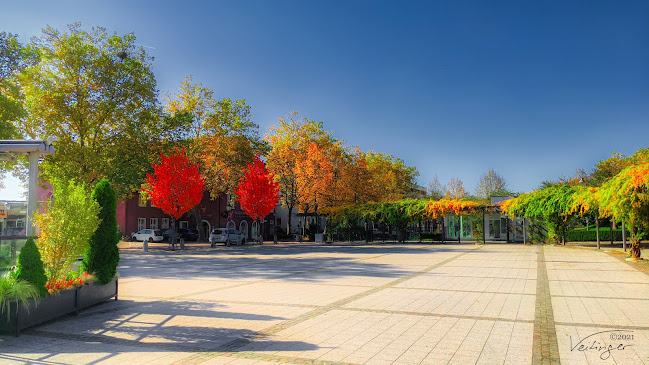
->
[17,24,162,199]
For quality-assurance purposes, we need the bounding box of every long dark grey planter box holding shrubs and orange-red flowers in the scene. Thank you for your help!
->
[0,278,118,336]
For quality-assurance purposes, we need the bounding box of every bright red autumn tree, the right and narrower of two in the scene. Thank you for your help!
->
[235,156,279,242]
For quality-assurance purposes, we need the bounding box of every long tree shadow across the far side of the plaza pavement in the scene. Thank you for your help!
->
[118,245,474,282]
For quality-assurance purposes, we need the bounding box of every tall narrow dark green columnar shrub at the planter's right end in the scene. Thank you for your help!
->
[83,179,119,284]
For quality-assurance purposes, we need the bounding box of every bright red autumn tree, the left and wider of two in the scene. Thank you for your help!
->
[142,149,205,239]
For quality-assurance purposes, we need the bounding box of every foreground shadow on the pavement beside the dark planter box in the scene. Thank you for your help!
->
[0,300,318,356]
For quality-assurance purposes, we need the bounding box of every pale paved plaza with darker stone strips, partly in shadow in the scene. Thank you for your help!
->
[0,244,649,365]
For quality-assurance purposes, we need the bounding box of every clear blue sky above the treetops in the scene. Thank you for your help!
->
[0,0,649,198]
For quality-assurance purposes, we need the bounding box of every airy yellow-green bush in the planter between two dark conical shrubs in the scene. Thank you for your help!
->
[34,180,99,284]
